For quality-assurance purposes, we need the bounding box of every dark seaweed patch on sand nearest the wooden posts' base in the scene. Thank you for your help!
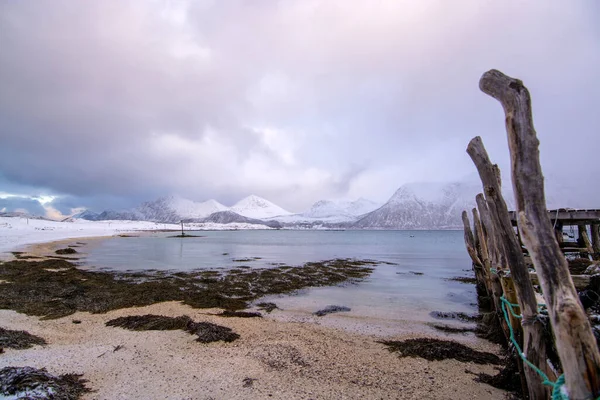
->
[379,338,501,365]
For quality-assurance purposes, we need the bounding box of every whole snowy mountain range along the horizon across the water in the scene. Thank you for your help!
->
[74,182,512,229]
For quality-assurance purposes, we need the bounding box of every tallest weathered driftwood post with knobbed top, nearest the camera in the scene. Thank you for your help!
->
[479,70,600,400]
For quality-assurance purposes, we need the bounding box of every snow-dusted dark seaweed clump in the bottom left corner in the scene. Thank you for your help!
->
[0,367,90,400]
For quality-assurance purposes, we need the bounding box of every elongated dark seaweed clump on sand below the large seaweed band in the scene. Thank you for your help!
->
[106,314,240,343]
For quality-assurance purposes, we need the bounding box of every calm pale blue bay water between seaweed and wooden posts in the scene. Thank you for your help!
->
[86,230,476,334]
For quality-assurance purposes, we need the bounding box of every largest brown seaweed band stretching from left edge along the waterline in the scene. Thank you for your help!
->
[0,259,377,319]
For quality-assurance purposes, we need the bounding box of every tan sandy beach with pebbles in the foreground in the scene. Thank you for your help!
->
[0,231,507,399]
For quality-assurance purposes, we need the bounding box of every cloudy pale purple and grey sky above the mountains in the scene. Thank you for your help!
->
[0,0,600,216]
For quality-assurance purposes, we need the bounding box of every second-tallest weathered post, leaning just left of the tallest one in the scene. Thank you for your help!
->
[467,136,547,400]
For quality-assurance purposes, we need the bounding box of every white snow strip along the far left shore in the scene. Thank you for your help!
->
[0,217,270,256]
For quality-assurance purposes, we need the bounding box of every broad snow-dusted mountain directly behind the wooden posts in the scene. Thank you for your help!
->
[351,182,513,229]
